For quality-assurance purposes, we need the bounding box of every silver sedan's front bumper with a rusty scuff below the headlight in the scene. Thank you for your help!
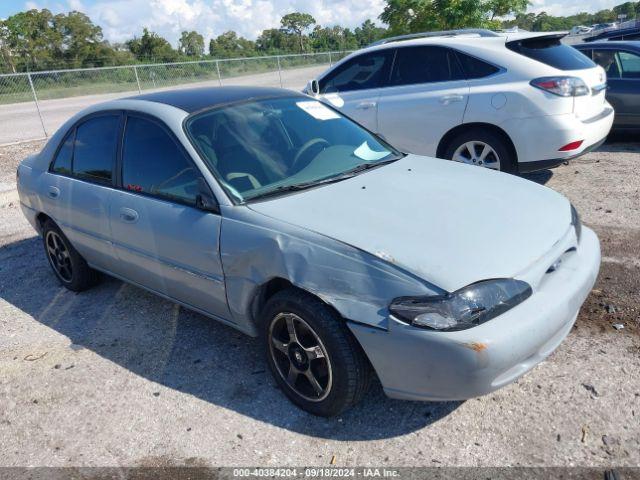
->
[349,228,600,401]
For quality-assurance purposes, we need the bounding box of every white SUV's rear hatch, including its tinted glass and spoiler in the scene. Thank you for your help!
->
[506,33,607,121]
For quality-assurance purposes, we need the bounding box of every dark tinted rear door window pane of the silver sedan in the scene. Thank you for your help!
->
[73,115,120,183]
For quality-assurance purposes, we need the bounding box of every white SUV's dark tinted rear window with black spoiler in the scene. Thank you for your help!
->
[507,38,596,70]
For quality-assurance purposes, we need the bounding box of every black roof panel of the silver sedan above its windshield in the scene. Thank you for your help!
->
[127,86,304,113]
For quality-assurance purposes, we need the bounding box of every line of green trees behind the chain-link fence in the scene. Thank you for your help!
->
[0,0,640,73]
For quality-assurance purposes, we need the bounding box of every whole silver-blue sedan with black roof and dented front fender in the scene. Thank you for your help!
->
[18,87,600,416]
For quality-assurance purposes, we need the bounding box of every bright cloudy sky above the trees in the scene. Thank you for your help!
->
[0,0,624,45]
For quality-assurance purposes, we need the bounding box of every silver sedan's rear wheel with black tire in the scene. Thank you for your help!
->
[42,220,99,292]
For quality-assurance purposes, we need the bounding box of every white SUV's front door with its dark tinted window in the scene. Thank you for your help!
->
[319,49,393,132]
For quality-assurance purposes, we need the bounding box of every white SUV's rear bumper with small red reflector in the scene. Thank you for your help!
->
[500,105,614,172]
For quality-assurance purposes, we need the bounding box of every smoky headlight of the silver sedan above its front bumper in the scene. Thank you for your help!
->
[389,278,532,331]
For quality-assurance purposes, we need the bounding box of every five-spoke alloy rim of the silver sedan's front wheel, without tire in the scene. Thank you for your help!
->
[268,313,333,402]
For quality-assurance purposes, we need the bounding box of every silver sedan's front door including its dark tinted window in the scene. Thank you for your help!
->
[110,114,230,319]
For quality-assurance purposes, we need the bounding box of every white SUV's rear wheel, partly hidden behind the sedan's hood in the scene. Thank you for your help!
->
[444,129,517,173]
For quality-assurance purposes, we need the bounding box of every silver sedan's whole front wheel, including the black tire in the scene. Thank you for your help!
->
[261,288,373,417]
